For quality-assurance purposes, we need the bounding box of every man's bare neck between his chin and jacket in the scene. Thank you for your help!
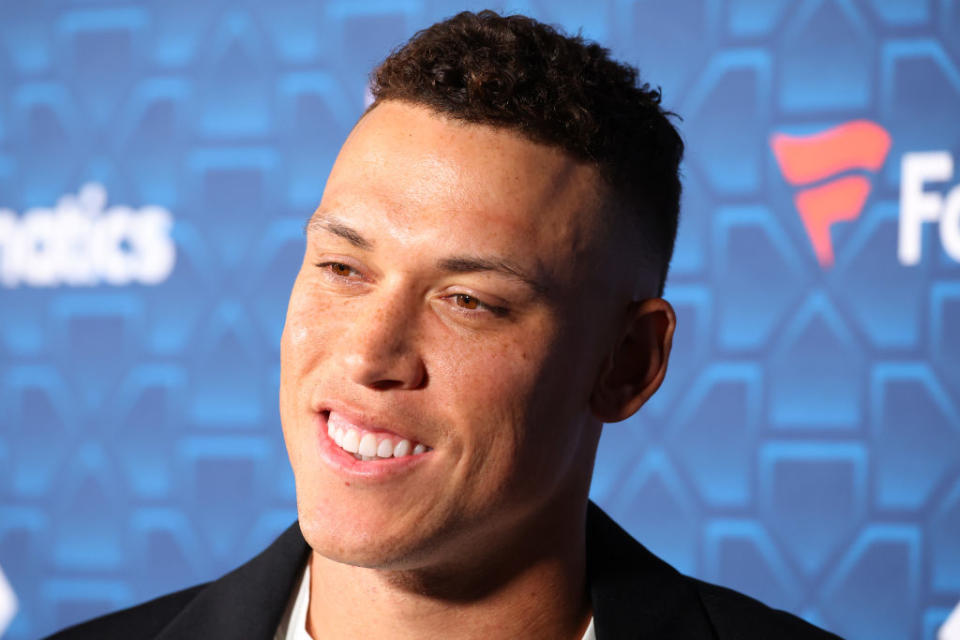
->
[307,508,591,640]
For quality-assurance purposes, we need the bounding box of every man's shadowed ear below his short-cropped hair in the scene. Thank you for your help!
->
[590,298,677,422]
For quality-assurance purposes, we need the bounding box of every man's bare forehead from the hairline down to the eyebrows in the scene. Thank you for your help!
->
[316,101,640,290]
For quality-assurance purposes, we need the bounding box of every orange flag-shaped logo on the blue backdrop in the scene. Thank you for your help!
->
[770,120,890,268]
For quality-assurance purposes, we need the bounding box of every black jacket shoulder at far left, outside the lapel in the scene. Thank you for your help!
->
[47,583,209,640]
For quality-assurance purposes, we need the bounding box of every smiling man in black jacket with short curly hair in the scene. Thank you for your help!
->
[48,12,830,640]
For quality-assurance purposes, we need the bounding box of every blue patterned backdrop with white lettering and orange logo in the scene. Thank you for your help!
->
[0,0,960,640]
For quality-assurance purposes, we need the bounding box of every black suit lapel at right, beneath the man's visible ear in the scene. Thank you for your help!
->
[587,502,714,640]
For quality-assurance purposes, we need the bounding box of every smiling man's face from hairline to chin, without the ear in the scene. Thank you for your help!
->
[280,101,632,568]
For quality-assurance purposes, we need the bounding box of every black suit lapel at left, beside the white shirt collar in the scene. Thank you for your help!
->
[157,522,309,640]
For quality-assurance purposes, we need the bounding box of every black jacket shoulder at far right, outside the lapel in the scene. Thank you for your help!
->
[687,578,839,640]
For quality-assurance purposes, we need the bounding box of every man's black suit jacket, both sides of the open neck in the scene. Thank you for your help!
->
[50,503,837,640]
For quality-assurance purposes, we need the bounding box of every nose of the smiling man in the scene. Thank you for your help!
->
[341,291,427,390]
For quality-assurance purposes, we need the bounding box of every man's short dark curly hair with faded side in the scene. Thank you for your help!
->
[371,11,683,295]
